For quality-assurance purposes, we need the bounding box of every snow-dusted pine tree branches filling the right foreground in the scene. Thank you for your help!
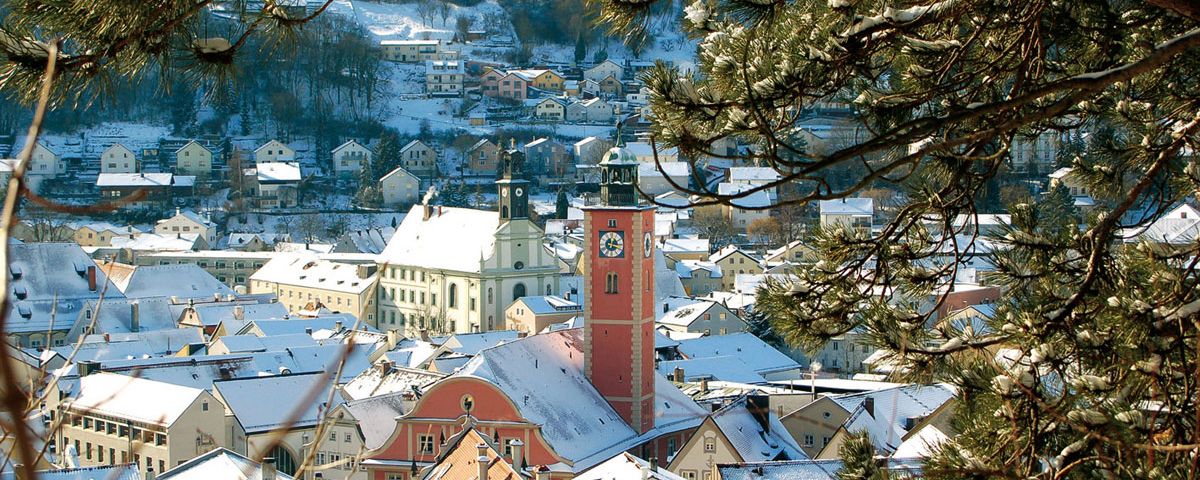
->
[596,0,1200,479]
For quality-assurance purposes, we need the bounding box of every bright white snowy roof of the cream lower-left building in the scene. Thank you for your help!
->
[65,372,204,425]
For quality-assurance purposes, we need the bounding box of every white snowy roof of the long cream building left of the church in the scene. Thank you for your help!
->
[250,253,376,295]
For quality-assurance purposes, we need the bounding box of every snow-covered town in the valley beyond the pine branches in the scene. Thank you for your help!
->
[0,0,1200,480]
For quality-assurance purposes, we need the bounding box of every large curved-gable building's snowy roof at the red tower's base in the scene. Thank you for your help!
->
[451,329,704,472]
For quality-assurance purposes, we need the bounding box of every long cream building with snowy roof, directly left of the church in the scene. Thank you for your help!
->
[250,254,376,326]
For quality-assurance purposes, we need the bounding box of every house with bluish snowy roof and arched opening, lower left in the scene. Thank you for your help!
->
[212,372,341,475]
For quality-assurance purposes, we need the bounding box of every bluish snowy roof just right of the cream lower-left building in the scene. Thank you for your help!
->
[212,371,340,434]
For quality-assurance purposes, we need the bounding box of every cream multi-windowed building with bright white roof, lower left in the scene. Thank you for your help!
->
[52,372,227,474]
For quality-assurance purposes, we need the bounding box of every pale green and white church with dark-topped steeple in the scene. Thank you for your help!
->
[377,149,558,336]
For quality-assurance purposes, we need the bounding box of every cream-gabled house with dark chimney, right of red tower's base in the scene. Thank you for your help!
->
[667,395,809,480]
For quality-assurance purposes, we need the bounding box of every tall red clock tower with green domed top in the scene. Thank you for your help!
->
[583,135,655,433]
